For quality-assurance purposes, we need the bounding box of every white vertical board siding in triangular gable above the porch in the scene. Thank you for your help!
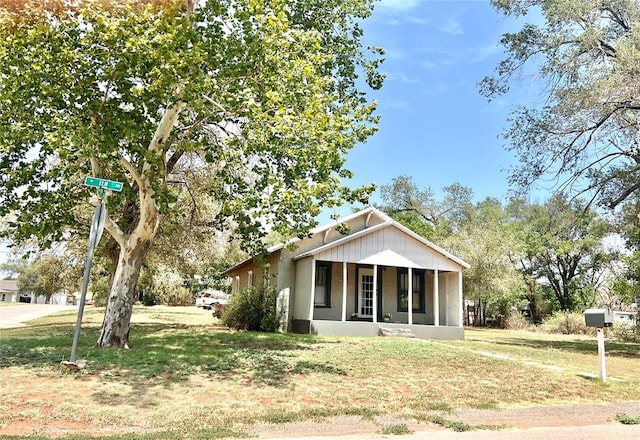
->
[315,226,461,271]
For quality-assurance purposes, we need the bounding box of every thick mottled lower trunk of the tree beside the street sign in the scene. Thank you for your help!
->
[97,238,150,348]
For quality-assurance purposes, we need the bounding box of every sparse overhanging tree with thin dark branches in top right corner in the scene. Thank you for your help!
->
[480,0,640,207]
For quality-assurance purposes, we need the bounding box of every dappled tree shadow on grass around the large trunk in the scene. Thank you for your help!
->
[0,324,345,390]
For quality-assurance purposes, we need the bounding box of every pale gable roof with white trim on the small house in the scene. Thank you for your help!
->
[224,207,471,274]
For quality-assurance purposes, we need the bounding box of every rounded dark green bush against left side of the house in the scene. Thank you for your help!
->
[222,286,280,332]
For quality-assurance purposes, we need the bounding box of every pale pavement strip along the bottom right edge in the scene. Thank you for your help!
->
[246,402,640,440]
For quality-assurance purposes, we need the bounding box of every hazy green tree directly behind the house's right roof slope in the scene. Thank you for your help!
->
[381,176,524,325]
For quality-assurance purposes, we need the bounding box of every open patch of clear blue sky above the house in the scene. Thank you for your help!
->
[323,0,540,217]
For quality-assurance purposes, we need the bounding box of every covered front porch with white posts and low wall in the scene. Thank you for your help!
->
[292,255,464,339]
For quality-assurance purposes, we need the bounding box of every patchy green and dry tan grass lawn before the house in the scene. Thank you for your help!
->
[0,307,640,438]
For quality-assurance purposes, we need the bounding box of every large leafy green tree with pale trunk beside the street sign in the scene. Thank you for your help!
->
[0,0,382,347]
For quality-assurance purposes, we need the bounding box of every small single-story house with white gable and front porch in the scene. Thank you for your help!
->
[225,208,469,339]
